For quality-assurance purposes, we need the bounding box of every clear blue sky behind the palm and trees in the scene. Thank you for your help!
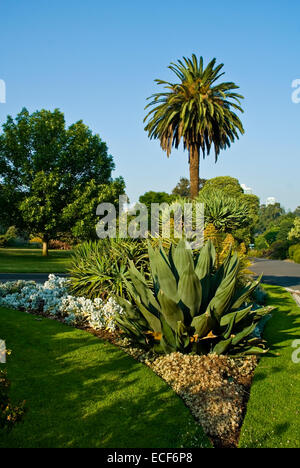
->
[0,0,300,209]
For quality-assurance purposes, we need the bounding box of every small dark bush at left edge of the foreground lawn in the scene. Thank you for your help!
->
[0,370,25,431]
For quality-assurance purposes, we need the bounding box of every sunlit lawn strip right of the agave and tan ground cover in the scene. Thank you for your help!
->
[240,286,300,448]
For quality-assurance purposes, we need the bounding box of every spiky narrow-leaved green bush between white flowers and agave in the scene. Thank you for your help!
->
[69,238,149,299]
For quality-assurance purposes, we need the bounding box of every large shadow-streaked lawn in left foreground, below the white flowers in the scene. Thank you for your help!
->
[0,309,210,448]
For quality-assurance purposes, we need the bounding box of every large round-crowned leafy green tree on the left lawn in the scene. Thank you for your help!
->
[0,109,123,255]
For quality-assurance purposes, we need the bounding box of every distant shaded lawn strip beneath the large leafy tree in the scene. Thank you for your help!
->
[0,249,71,273]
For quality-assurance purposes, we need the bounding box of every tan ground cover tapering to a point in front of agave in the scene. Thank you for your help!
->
[88,329,258,448]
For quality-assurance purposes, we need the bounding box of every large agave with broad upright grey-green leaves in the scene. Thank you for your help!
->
[117,240,272,355]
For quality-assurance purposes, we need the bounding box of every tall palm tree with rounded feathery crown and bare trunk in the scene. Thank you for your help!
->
[144,54,244,198]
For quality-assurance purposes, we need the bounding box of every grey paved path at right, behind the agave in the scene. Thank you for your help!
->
[250,258,300,291]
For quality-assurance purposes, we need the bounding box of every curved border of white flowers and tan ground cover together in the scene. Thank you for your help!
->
[0,275,257,447]
